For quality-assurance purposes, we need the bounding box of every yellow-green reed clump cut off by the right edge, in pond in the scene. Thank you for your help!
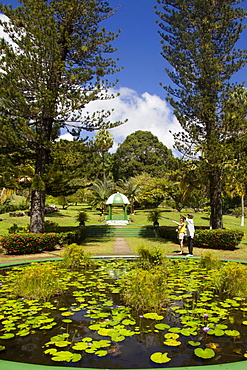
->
[213,262,247,297]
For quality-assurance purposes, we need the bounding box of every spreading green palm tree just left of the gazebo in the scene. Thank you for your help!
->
[88,178,115,216]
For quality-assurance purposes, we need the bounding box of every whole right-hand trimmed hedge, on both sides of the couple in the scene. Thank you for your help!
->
[159,226,244,250]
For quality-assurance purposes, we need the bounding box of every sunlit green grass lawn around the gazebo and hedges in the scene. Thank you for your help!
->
[0,204,247,260]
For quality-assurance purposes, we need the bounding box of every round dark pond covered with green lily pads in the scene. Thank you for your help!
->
[0,260,247,369]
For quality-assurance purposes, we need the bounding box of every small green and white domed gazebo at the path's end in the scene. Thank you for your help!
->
[106,193,130,225]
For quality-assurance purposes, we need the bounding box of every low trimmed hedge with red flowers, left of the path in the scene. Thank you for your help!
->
[0,227,86,255]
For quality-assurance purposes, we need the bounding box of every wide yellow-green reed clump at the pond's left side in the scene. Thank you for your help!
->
[12,262,64,301]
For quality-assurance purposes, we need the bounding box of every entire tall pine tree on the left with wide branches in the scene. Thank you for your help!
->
[0,0,122,233]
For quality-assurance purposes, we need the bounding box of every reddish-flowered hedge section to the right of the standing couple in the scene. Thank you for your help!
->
[194,229,244,250]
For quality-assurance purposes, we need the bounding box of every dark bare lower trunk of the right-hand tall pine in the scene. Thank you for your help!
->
[209,167,223,229]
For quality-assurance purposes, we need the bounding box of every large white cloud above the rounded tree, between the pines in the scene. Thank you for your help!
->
[82,87,181,152]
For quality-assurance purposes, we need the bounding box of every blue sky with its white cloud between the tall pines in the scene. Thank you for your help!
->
[0,0,247,155]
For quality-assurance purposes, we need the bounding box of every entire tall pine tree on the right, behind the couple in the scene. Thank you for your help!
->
[156,0,246,229]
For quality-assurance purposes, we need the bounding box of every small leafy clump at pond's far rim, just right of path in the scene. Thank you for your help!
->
[137,245,166,267]
